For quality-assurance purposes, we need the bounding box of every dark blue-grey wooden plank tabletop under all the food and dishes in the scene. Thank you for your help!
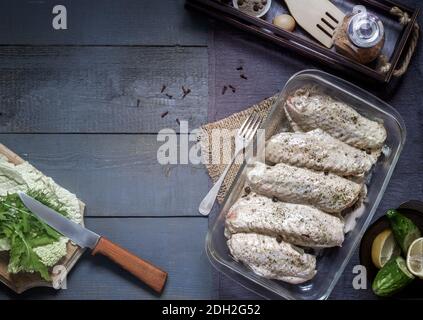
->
[0,0,423,299]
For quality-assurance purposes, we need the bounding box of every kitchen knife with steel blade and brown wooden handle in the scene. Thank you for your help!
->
[18,192,167,293]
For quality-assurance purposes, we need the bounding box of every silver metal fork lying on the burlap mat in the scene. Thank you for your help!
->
[198,112,262,216]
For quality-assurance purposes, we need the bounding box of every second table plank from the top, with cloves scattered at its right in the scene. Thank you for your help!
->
[0,47,208,133]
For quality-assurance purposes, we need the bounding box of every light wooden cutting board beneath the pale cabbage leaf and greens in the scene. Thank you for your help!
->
[0,144,85,293]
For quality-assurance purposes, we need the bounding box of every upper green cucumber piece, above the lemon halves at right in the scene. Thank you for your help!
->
[386,209,421,255]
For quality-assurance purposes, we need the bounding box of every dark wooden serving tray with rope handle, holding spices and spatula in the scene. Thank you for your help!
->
[186,0,420,82]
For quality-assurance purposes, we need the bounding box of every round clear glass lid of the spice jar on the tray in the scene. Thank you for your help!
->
[347,6,385,48]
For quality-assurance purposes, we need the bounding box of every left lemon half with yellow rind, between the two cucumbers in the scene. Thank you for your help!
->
[372,229,401,269]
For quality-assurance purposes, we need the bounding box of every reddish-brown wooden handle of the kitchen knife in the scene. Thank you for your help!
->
[92,237,167,293]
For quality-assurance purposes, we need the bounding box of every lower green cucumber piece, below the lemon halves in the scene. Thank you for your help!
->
[372,257,414,297]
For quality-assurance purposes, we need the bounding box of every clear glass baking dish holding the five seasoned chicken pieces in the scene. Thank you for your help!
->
[206,70,406,300]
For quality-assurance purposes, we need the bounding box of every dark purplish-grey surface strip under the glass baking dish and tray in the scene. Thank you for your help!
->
[209,0,423,300]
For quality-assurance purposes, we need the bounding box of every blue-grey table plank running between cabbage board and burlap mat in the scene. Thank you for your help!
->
[0,134,209,216]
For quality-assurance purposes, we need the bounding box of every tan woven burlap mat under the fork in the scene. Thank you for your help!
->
[199,95,278,203]
